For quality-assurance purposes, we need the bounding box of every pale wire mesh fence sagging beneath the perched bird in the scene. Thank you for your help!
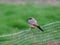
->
[0,21,60,45]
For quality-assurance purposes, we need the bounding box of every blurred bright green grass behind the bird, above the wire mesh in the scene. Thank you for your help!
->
[0,4,60,35]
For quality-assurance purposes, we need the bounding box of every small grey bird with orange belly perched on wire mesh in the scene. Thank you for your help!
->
[28,17,44,31]
